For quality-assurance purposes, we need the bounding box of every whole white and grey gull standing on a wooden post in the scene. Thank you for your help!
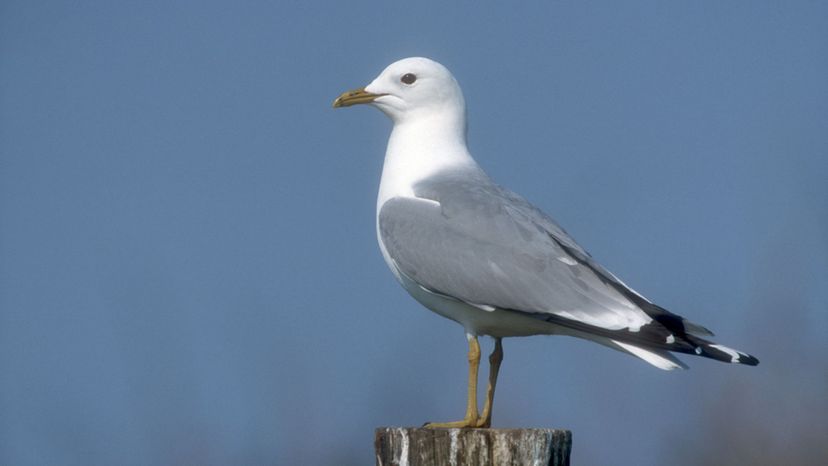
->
[333,57,759,428]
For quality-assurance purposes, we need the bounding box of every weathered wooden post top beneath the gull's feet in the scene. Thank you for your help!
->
[374,427,572,466]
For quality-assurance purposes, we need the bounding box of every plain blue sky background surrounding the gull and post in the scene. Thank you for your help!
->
[0,1,828,465]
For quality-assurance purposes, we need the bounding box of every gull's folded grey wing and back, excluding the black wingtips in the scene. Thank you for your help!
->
[379,174,652,330]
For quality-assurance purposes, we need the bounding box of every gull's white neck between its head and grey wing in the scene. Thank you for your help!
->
[377,112,479,211]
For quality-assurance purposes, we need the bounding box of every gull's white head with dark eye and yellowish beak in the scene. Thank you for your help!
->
[333,57,466,126]
